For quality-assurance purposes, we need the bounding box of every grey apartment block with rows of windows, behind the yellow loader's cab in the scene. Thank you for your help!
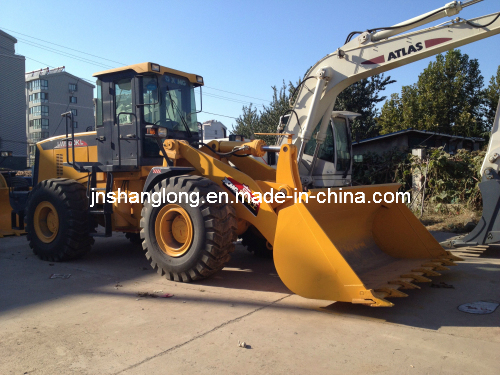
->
[25,66,95,165]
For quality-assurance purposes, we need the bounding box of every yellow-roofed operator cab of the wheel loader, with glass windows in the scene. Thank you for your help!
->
[94,62,203,171]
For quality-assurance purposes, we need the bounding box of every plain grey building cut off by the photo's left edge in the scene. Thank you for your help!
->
[0,30,26,169]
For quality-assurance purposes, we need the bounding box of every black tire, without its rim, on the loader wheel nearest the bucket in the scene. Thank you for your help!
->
[141,176,237,282]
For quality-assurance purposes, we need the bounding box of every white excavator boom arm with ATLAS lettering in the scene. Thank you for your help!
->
[281,1,500,187]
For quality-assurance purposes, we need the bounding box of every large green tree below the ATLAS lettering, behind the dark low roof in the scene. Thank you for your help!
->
[378,50,484,136]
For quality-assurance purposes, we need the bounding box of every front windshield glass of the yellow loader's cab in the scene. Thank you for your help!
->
[142,74,198,133]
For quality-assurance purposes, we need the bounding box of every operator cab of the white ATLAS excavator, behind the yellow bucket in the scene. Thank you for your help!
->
[303,111,360,187]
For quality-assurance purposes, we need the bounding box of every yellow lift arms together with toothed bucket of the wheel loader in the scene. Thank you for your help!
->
[159,140,460,306]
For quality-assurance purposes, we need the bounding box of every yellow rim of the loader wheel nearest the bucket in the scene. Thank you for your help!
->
[155,204,193,257]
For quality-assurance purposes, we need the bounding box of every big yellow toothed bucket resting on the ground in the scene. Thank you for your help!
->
[274,184,461,306]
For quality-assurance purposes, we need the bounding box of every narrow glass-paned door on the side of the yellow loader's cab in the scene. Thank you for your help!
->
[111,75,140,167]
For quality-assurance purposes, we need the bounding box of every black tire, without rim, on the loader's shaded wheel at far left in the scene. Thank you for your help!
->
[24,178,94,262]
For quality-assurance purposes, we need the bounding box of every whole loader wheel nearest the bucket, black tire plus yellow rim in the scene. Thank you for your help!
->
[141,176,236,282]
